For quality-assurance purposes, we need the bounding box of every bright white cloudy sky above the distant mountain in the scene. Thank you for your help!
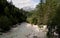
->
[7,0,40,8]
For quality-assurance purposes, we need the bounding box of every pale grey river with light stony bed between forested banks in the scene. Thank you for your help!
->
[0,22,46,38]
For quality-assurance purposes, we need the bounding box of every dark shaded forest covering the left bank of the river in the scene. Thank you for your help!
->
[0,0,28,32]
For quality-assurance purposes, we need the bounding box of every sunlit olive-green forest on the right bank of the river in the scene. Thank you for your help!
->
[27,0,60,38]
